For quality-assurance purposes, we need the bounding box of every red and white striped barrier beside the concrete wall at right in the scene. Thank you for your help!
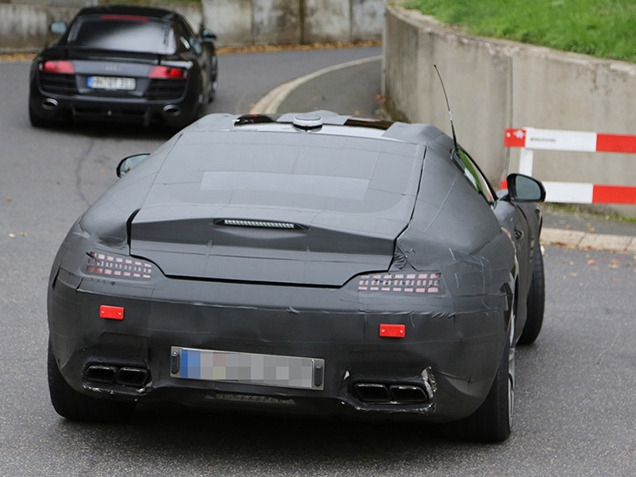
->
[504,128,636,205]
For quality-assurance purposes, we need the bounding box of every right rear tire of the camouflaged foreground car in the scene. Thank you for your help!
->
[466,320,515,442]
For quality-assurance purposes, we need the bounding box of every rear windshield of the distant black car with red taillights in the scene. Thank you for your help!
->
[67,15,175,54]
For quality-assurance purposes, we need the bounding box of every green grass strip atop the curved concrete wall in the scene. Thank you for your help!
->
[406,0,636,63]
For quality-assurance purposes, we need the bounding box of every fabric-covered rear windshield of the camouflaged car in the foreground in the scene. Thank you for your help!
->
[148,126,424,217]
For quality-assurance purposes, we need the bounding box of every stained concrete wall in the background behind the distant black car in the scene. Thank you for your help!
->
[0,0,386,53]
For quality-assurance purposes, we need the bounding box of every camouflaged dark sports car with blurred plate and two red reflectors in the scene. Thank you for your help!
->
[48,111,545,441]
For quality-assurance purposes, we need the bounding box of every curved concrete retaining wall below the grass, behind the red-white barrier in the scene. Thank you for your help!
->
[383,6,636,209]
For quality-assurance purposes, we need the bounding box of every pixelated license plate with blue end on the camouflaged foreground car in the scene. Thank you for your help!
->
[170,346,325,390]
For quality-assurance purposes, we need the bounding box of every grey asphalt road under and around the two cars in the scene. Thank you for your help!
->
[0,48,636,477]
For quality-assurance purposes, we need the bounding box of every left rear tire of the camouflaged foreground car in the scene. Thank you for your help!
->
[47,343,135,422]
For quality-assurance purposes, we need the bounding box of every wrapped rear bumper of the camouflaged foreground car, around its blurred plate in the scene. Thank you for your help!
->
[49,264,507,421]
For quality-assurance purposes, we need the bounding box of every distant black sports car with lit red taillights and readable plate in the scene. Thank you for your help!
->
[29,6,218,128]
